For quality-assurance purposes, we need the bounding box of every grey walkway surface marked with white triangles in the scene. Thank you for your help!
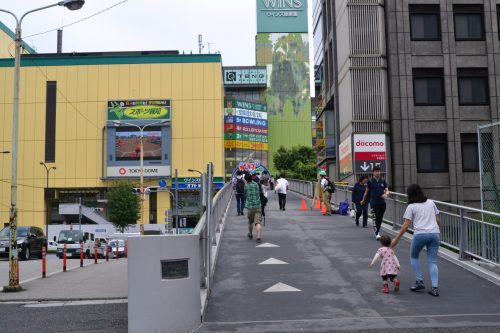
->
[197,193,500,332]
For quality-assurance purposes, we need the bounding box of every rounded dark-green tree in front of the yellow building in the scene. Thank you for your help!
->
[107,181,140,232]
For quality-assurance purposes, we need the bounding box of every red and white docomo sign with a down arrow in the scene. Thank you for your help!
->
[353,133,387,173]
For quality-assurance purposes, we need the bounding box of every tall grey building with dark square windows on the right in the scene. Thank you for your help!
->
[314,0,500,206]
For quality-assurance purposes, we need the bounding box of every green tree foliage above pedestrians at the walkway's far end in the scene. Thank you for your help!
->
[273,146,318,180]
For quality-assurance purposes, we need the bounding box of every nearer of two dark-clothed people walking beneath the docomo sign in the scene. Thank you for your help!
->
[361,165,389,240]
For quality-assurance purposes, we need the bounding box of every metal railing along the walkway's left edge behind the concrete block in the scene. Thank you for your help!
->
[193,163,233,315]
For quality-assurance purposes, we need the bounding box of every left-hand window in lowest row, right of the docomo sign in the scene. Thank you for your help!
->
[416,134,448,172]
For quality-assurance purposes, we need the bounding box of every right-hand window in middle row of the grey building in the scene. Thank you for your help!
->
[457,68,490,105]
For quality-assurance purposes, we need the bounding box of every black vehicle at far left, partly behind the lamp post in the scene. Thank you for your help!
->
[0,226,47,260]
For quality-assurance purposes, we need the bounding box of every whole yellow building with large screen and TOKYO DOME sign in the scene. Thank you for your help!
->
[0,43,224,231]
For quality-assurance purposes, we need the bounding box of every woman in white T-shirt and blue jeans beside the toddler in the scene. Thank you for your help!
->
[391,184,440,296]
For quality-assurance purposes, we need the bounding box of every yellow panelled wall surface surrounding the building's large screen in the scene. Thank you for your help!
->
[0,56,224,226]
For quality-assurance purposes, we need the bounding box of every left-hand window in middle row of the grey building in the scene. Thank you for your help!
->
[413,68,444,105]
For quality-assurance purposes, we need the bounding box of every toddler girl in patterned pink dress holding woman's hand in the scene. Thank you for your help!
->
[370,235,399,294]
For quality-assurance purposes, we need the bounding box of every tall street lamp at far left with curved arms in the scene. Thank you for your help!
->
[0,0,85,291]
